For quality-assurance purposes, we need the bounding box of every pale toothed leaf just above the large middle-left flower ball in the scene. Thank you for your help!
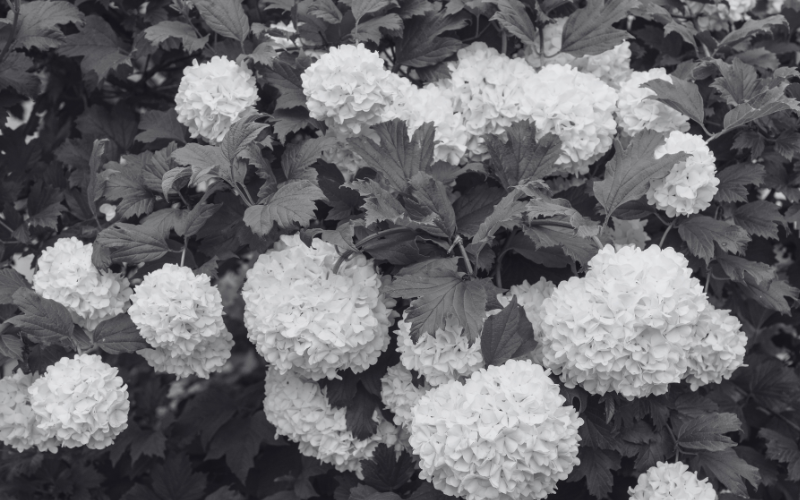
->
[244,180,325,236]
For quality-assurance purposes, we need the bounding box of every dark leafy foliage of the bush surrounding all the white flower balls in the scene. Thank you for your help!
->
[0,0,800,500]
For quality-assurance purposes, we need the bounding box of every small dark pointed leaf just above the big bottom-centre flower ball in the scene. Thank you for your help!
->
[481,295,536,366]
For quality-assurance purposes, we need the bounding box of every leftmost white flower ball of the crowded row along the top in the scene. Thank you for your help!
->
[302,44,413,137]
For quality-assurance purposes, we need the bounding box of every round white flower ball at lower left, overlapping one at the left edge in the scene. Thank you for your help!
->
[28,354,130,450]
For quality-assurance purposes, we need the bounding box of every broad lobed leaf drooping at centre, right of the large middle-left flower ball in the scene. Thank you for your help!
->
[386,259,486,343]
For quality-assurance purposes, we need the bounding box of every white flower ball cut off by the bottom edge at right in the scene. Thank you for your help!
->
[628,462,717,500]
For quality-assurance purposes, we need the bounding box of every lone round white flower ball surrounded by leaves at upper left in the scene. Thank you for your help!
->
[175,56,258,143]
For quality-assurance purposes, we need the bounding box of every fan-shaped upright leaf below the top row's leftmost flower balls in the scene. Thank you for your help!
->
[347,119,435,191]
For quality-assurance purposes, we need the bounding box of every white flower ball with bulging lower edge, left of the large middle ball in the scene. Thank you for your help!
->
[128,264,233,378]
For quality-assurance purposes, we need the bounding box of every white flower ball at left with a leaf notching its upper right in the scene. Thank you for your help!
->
[33,237,132,330]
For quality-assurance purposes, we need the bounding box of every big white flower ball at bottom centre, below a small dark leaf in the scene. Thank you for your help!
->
[409,360,583,500]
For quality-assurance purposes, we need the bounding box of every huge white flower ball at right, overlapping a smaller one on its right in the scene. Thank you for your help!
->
[540,245,707,399]
